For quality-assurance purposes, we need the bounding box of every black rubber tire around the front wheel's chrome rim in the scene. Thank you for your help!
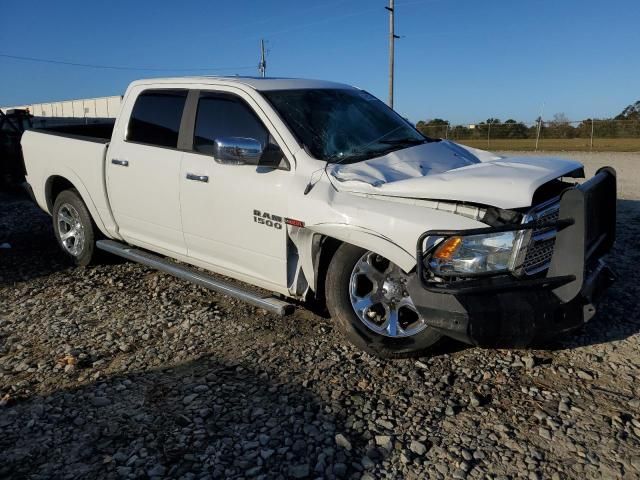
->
[326,244,441,358]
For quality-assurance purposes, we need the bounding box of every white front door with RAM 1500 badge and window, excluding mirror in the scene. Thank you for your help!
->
[180,91,292,290]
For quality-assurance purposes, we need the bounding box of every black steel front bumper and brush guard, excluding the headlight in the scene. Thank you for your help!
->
[408,167,616,348]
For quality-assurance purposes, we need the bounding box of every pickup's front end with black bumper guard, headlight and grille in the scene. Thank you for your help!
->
[408,167,616,347]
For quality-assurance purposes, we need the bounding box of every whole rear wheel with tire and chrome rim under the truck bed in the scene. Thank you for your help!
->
[52,190,98,267]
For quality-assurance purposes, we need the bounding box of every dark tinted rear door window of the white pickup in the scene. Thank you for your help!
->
[127,90,187,148]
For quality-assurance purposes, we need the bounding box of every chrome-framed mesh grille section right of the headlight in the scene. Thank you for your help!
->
[522,202,560,275]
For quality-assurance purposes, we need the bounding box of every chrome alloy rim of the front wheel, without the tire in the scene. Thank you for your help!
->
[349,252,427,337]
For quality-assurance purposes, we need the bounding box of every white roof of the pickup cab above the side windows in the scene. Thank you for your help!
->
[134,76,354,91]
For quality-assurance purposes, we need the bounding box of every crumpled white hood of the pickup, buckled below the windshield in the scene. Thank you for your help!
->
[329,140,584,208]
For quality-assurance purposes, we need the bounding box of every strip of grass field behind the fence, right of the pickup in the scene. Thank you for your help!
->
[450,138,640,152]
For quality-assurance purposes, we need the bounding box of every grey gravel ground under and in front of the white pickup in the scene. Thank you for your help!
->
[0,167,640,479]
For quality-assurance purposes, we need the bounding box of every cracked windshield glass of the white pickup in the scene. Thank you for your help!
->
[262,89,428,163]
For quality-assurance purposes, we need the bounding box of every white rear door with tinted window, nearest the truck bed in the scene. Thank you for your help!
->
[106,89,188,255]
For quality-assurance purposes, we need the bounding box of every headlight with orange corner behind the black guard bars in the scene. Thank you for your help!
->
[429,232,517,276]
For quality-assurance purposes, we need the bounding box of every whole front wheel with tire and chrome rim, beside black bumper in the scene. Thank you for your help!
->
[325,244,442,358]
